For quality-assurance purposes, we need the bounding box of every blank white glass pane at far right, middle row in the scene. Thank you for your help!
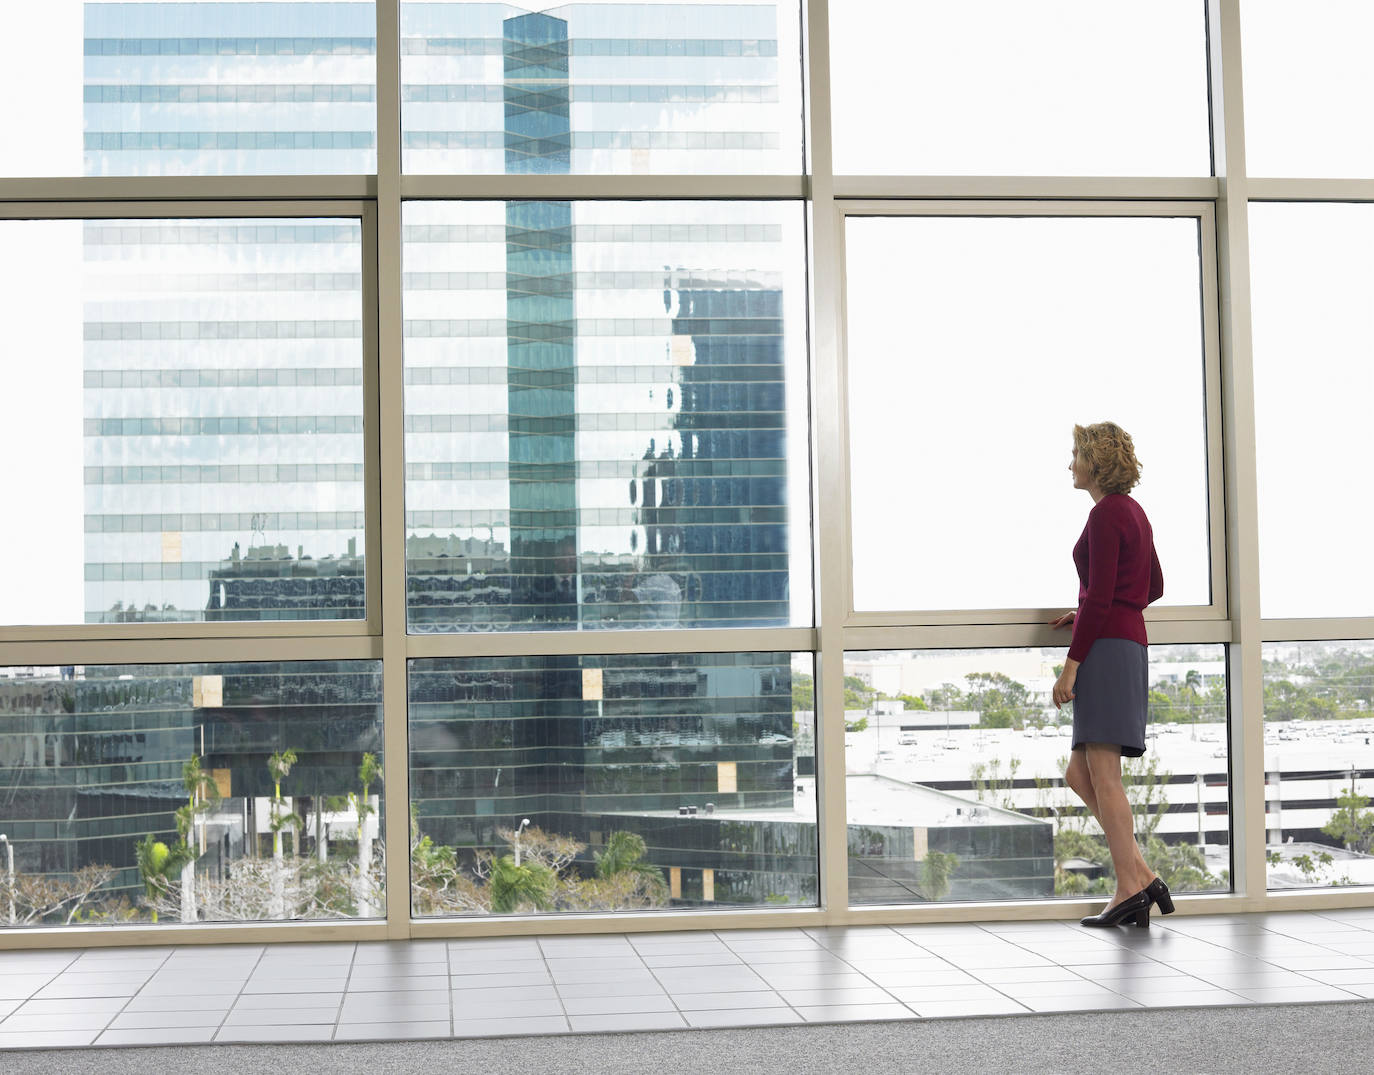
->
[1250,203,1374,617]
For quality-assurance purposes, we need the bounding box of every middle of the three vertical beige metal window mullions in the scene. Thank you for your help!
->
[804,0,849,924]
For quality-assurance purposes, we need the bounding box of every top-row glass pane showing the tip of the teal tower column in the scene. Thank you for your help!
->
[401,0,801,175]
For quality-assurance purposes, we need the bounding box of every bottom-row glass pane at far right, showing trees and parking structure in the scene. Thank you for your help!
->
[1264,639,1374,889]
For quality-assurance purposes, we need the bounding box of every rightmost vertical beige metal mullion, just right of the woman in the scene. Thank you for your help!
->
[1208,0,1267,902]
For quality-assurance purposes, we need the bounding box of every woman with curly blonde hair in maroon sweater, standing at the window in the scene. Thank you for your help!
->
[1050,422,1173,928]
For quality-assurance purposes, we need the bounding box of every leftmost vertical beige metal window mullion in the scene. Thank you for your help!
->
[375,0,411,939]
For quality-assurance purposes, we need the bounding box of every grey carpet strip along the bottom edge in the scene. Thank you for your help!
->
[0,1004,1374,1075]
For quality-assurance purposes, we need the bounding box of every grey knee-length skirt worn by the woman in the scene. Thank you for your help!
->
[1073,638,1150,757]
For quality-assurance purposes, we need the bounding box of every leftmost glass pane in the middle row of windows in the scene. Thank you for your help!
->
[0,220,364,624]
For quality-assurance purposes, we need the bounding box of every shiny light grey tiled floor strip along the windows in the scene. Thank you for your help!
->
[0,909,1374,1049]
